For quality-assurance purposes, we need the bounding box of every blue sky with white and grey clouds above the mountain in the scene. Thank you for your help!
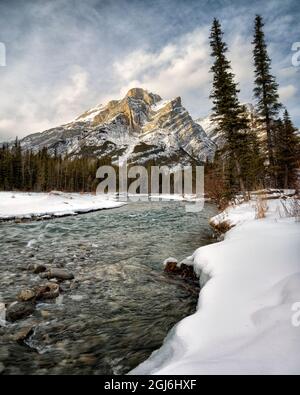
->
[0,0,300,141]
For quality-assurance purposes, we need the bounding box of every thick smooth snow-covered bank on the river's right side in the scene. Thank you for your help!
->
[131,200,300,375]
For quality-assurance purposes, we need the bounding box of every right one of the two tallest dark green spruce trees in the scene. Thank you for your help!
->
[253,15,281,186]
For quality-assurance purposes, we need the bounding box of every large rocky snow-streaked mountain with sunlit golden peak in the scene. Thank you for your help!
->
[21,88,216,166]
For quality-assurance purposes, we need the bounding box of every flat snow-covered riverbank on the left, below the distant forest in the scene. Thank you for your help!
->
[0,192,123,221]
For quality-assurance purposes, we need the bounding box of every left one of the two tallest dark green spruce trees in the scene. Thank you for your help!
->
[210,19,249,193]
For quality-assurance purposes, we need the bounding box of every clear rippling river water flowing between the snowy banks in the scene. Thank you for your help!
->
[0,202,216,374]
